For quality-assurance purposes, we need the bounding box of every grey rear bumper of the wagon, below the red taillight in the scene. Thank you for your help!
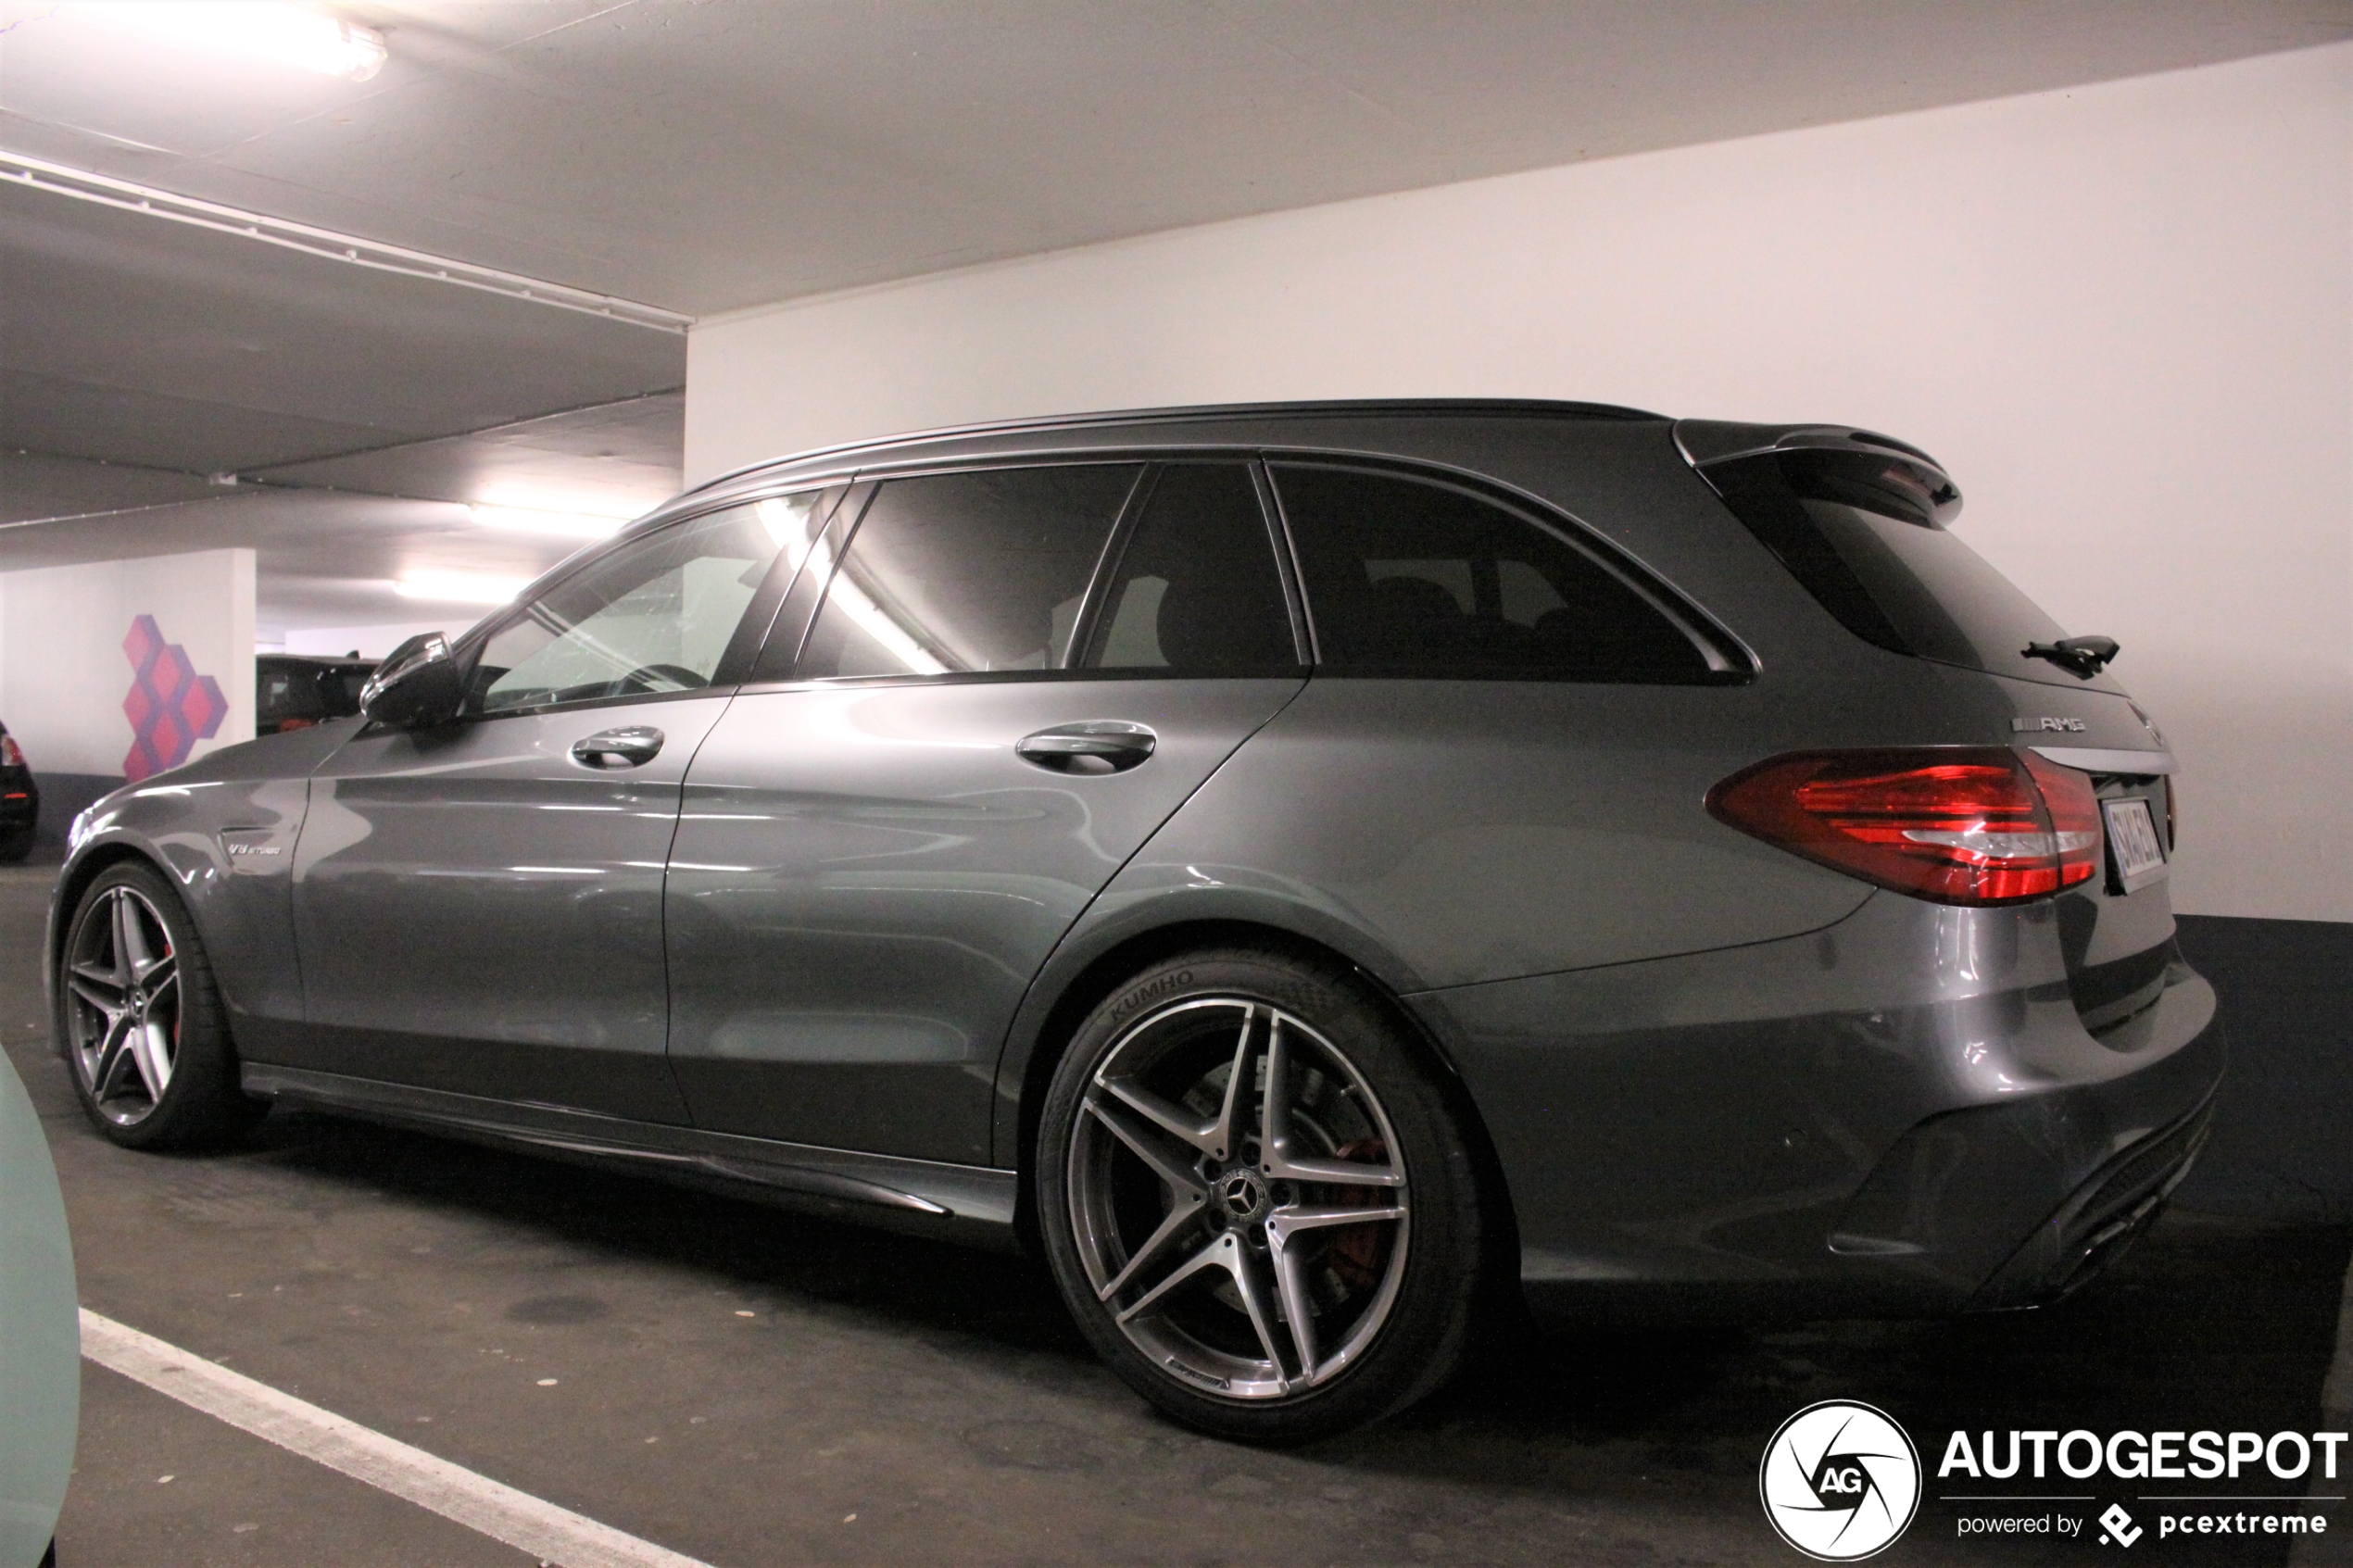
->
[1407,894,2226,1321]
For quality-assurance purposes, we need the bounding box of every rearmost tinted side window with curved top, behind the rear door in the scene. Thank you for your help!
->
[1271,463,1718,682]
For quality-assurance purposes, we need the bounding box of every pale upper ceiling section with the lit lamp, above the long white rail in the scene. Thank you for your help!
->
[0,0,2353,315]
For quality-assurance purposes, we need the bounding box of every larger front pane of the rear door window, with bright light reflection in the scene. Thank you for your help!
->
[793,463,1141,680]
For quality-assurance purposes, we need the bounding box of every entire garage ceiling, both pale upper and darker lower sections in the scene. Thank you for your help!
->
[0,0,2353,621]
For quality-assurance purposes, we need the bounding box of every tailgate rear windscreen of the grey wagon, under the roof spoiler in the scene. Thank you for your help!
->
[1704,449,2073,684]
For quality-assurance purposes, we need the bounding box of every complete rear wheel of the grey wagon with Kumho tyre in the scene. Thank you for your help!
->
[1036,949,1480,1441]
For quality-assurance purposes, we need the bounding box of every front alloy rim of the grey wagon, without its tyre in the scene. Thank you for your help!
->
[66,886,179,1126]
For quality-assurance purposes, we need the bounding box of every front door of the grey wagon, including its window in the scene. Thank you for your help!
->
[295,494,828,1122]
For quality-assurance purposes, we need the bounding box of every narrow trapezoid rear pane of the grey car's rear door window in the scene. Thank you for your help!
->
[1076,463,1299,674]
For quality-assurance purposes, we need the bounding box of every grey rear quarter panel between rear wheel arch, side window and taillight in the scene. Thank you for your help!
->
[1108,680,1870,990]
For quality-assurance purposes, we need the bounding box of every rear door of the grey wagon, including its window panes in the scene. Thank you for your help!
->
[666,460,1306,1163]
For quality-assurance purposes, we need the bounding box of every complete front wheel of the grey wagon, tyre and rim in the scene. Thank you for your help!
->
[57,860,263,1149]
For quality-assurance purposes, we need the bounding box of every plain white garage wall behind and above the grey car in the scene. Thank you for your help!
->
[687,44,2353,919]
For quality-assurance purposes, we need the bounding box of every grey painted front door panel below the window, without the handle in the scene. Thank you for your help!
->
[289,696,727,1122]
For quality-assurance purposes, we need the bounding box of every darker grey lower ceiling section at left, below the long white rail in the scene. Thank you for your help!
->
[0,172,685,472]
